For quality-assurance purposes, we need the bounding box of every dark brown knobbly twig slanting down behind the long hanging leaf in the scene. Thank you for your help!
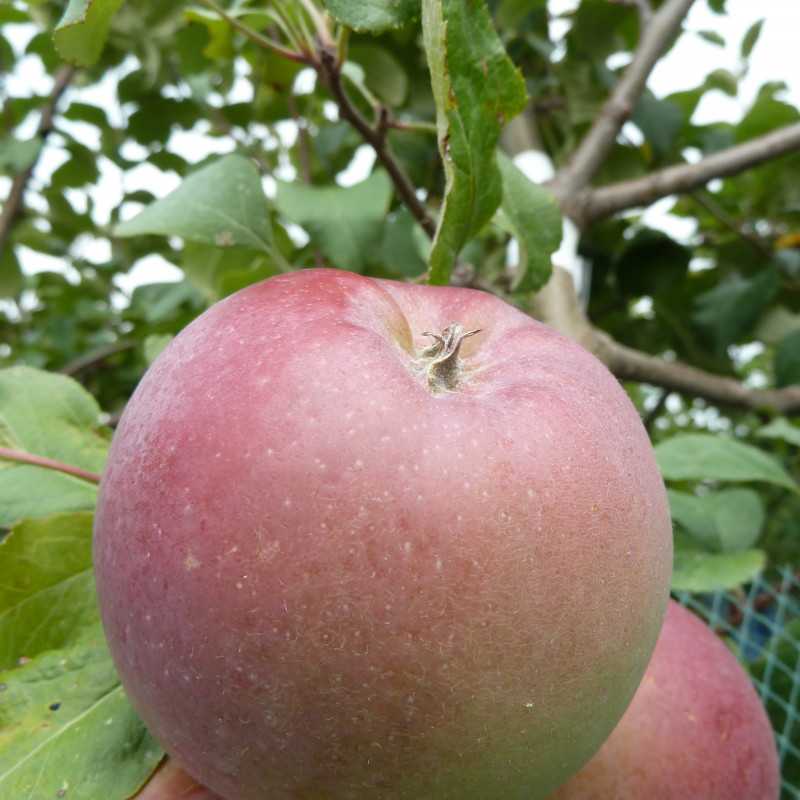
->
[317,49,436,239]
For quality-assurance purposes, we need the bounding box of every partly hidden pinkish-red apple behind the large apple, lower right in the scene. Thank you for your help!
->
[550,601,780,800]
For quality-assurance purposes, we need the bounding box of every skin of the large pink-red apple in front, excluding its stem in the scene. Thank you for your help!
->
[94,270,672,800]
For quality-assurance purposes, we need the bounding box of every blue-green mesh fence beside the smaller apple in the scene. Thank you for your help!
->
[676,567,800,800]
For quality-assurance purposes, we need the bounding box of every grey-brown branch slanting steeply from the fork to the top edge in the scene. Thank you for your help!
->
[552,0,694,197]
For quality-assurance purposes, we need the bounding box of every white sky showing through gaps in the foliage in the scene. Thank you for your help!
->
[0,0,800,293]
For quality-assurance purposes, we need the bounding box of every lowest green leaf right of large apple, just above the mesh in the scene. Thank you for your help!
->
[672,535,766,592]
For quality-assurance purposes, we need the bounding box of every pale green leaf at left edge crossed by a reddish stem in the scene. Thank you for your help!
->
[0,367,109,526]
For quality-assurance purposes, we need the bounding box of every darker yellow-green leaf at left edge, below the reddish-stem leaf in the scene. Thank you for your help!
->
[0,512,98,670]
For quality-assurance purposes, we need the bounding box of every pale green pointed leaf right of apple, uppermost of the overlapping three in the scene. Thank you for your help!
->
[655,433,797,492]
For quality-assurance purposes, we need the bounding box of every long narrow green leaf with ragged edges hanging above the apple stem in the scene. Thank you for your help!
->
[422,0,527,284]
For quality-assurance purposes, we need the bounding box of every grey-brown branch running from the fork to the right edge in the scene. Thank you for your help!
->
[584,122,800,224]
